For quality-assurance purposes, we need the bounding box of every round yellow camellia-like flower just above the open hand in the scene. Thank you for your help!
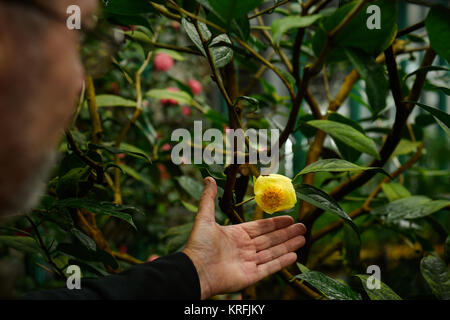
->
[254,174,297,214]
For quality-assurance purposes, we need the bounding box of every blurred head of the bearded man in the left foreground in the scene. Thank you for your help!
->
[0,0,97,216]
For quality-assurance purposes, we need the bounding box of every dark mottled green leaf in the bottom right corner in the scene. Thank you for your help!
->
[420,254,450,300]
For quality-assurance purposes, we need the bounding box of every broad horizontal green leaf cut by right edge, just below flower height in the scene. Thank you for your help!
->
[372,196,450,222]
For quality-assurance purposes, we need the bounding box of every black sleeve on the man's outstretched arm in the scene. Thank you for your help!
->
[24,252,200,300]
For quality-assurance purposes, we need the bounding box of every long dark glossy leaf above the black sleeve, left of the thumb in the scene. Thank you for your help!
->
[54,198,140,229]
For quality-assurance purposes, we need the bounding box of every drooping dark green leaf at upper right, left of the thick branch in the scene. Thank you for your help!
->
[345,49,389,115]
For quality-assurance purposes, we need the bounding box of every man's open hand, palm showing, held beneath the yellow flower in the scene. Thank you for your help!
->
[183,177,306,299]
